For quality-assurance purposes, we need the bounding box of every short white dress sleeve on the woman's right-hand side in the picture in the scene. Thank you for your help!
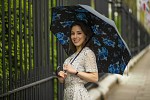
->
[85,50,98,72]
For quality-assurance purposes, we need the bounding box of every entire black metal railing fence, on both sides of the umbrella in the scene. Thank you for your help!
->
[0,0,150,100]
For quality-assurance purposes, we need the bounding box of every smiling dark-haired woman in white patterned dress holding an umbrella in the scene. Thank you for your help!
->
[58,22,98,100]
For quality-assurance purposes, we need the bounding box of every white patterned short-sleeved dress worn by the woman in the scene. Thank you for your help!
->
[64,47,98,100]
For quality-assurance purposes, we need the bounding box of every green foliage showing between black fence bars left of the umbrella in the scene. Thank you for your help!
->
[0,0,57,100]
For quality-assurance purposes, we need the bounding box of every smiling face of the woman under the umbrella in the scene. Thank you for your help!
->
[71,25,86,49]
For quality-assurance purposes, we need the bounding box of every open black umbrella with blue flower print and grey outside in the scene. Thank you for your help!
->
[50,5,131,75]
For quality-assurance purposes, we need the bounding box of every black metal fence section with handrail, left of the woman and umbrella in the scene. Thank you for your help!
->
[0,0,57,100]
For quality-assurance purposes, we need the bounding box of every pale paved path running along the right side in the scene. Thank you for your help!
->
[106,50,150,100]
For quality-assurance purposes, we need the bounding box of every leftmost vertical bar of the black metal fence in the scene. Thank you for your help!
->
[2,0,6,95]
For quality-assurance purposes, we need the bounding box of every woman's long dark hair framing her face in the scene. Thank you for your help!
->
[69,21,92,52]
